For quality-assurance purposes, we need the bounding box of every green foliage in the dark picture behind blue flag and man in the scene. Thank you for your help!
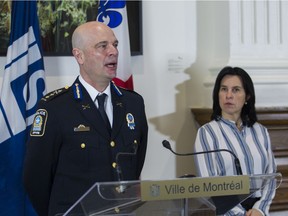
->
[0,0,98,55]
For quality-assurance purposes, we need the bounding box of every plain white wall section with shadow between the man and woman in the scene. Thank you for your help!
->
[138,1,196,179]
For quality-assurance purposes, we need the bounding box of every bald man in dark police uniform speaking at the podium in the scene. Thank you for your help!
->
[24,21,148,216]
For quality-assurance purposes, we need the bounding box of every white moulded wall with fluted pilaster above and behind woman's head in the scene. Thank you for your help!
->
[188,0,288,108]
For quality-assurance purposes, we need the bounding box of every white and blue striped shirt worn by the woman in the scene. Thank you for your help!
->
[195,118,276,215]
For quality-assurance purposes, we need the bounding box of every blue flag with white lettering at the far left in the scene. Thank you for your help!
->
[0,1,46,216]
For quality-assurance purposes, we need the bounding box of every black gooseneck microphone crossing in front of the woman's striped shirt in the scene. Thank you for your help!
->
[162,140,243,175]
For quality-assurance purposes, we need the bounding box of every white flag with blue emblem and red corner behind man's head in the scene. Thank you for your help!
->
[97,0,133,90]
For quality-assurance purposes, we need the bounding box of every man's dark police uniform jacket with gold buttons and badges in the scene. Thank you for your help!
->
[24,78,148,216]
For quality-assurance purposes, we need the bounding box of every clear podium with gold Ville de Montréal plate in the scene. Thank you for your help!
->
[57,173,282,216]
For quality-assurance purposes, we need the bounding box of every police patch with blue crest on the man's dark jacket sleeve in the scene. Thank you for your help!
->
[30,109,48,136]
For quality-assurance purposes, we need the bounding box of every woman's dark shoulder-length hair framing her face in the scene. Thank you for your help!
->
[211,66,257,127]
